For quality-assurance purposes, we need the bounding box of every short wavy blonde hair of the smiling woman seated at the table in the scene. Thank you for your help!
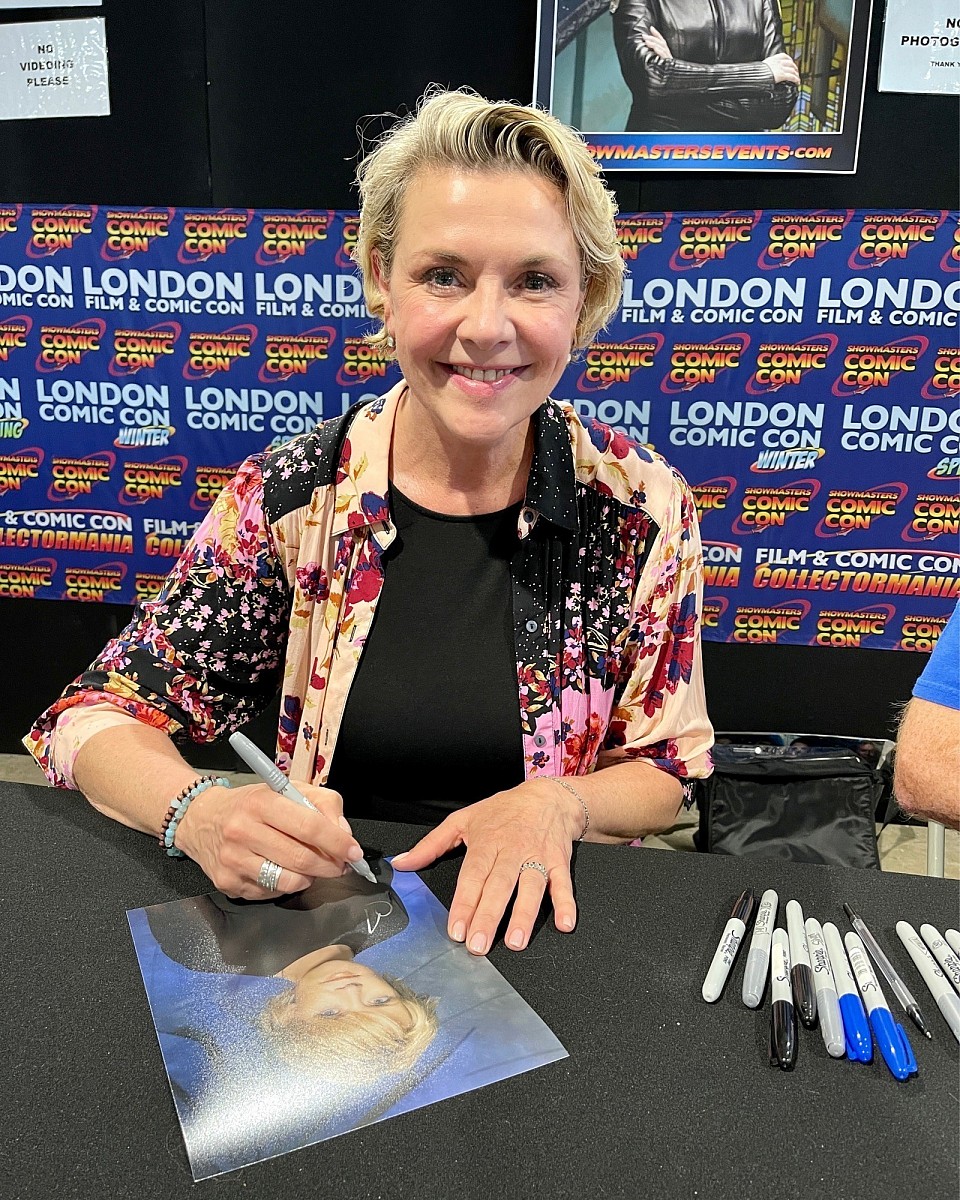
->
[354,89,624,350]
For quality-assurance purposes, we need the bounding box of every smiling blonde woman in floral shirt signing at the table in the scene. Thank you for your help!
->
[26,92,712,954]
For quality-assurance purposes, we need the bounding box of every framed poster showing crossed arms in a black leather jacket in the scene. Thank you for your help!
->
[534,0,870,174]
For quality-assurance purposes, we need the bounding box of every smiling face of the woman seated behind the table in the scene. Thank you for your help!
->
[374,169,583,456]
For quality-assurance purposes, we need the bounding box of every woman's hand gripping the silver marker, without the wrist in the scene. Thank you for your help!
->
[175,782,362,900]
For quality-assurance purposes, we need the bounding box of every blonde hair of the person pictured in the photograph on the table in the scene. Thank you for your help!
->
[259,976,439,1081]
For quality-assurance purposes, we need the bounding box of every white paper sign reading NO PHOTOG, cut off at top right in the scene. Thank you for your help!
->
[877,0,960,96]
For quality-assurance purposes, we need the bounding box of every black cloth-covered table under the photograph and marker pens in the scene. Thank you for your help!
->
[7,784,960,1200]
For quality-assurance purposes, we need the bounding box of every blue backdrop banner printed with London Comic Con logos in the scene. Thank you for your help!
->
[0,205,960,652]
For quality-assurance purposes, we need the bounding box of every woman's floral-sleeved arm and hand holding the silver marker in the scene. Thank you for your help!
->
[25,460,362,899]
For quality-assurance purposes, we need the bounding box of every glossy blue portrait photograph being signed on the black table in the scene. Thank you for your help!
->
[127,859,566,1180]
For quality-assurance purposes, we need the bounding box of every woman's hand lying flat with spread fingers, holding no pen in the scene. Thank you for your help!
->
[392,779,583,954]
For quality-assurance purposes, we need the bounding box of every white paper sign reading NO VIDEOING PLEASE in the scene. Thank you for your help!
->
[0,17,110,121]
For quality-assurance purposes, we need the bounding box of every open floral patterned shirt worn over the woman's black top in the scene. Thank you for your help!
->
[24,384,713,801]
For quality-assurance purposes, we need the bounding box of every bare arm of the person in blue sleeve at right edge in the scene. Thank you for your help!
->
[893,696,960,829]
